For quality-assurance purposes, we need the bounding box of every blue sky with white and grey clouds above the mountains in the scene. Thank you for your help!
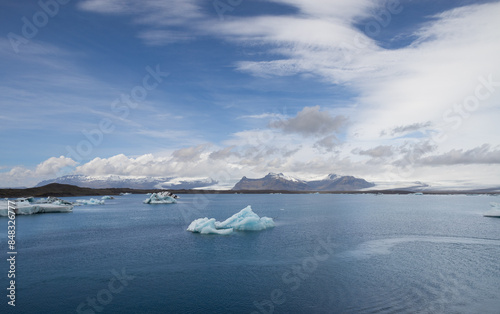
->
[0,0,500,187]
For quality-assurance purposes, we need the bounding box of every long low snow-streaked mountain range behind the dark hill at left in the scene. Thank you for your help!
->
[36,175,218,189]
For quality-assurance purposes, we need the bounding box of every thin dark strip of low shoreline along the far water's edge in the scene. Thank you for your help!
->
[0,183,500,198]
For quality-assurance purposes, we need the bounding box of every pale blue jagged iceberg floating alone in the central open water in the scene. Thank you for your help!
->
[187,205,275,234]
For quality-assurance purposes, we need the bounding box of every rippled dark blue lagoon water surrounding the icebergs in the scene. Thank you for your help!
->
[0,194,500,313]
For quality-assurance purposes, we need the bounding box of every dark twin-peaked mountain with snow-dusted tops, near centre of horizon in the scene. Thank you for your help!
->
[233,173,375,191]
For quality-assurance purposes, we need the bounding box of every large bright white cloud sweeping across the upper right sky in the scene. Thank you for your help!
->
[209,0,500,147]
